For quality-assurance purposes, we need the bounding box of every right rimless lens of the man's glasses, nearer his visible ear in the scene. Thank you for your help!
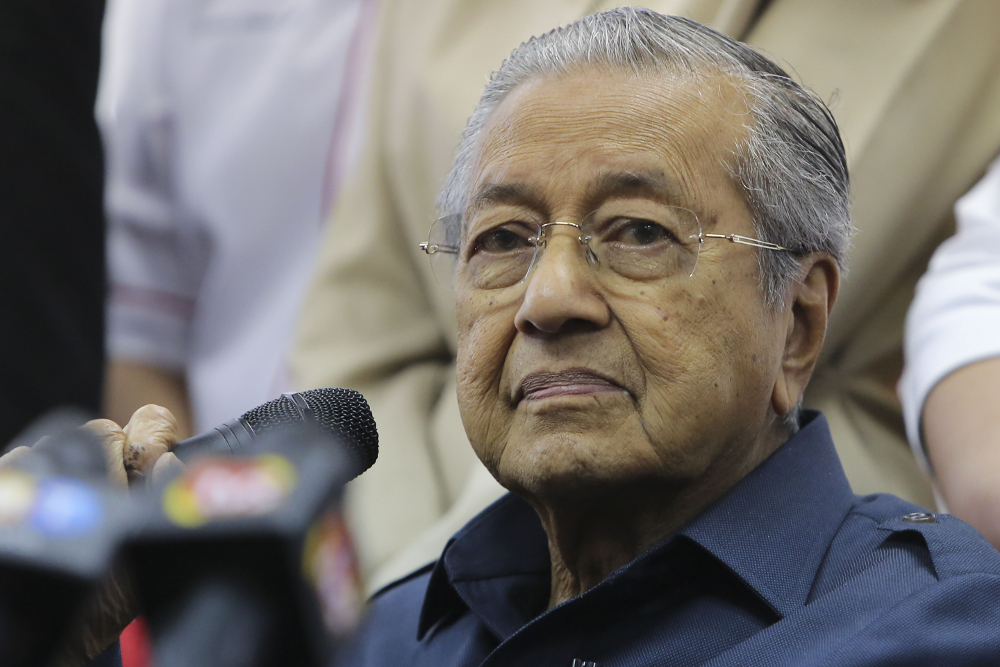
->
[581,202,701,281]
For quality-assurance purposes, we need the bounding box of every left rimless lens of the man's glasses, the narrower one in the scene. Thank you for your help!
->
[458,218,542,289]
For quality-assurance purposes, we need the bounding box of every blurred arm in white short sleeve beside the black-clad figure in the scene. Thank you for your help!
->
[96,0,204,438]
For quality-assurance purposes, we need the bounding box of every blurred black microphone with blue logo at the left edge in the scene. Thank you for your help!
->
[0,422,130,667]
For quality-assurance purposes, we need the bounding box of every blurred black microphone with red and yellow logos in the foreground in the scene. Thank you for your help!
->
[124,422,375,667]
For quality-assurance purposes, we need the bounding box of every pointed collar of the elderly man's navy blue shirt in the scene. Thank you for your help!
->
[418,411,854,639]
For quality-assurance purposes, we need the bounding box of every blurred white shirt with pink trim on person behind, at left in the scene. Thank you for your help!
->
[97,0,369,430]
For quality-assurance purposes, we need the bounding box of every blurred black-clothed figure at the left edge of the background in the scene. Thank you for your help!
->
[0,0,105,451]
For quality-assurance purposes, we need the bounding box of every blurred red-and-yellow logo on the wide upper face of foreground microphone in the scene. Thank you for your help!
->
[163,454,296,528]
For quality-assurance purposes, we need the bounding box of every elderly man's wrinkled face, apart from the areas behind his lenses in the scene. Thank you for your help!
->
[456,70,785,497]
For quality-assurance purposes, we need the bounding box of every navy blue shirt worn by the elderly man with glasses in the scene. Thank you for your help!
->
[339,413,1000,667]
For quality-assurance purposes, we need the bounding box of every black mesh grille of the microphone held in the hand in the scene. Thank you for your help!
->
[243,388,378,475]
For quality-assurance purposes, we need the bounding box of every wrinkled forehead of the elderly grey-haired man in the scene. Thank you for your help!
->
[469,68,750,214]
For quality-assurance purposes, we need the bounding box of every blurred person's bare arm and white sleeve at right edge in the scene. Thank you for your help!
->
[899,162,1000,548]
